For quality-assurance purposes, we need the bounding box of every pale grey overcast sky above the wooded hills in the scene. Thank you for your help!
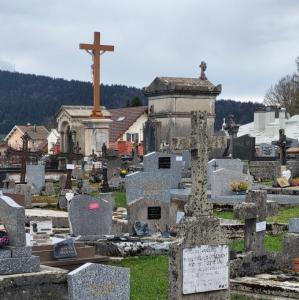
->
[0,0,299,101]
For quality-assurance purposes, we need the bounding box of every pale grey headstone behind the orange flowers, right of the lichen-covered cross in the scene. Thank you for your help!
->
[211,169,253,199]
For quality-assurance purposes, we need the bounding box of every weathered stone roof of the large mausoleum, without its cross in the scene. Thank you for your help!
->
[144,77,221,96]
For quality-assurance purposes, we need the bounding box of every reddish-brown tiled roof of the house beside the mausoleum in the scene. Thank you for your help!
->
[109,106,147,142]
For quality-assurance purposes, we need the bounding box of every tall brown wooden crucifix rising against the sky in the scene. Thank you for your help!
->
[80,32,114,118]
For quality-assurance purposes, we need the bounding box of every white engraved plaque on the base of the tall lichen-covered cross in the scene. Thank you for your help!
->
[183,245,229,294]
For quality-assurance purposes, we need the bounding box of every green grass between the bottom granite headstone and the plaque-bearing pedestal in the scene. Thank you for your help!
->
[112,256,168,300]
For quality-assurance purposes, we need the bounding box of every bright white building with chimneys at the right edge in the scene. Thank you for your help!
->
[238,107,299,145]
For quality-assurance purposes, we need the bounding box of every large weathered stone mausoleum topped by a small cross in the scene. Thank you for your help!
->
[144,62,221,151]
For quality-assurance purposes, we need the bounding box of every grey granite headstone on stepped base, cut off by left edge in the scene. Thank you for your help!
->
[0,195,40,275]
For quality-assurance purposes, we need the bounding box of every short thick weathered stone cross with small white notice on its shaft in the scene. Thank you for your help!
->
[234,190,278,256]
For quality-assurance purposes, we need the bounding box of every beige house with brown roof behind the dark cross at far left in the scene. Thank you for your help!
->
[4,124,49,151]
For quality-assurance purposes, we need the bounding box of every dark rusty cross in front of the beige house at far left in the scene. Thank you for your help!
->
[6,132,42,184]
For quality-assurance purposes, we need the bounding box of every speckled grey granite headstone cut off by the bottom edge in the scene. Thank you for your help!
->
[67,263,130,300]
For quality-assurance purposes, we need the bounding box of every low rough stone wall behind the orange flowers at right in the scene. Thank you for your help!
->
[249,161,279,180]
